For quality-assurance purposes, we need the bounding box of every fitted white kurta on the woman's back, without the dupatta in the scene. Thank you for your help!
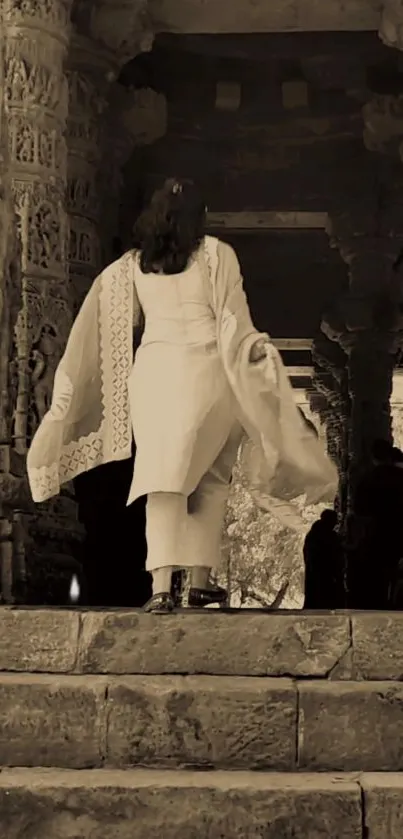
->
[127,249,240,504]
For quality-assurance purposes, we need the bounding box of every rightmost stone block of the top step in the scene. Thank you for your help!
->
[351,612,403,681]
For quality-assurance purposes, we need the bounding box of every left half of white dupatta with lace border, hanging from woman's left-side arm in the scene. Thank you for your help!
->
[27,252,141,502]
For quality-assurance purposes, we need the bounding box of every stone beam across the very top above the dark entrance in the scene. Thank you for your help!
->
[68,0,403,72]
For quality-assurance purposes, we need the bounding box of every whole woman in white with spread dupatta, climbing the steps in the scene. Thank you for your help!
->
[28,179,335,612]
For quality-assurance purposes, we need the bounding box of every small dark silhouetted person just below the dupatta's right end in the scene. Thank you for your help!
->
[304,510,345,609]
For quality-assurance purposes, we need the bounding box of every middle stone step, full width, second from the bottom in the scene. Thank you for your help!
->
[0,673,403,772]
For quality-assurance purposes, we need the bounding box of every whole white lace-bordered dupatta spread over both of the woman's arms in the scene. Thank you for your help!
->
[27,236,337,512]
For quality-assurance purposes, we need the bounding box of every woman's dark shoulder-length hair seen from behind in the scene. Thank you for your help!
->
[134,178,206,274]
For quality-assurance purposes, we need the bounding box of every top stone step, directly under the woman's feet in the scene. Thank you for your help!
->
[0,607,403,681]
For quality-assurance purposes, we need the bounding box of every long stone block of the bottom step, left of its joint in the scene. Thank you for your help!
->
[0,770,362,839]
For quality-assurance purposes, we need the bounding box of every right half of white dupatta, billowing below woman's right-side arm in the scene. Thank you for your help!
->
[201,237,338,520]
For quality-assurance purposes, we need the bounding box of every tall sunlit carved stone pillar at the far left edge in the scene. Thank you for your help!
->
[0,0,77,602]
